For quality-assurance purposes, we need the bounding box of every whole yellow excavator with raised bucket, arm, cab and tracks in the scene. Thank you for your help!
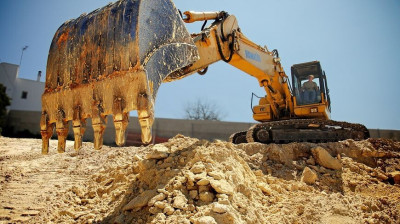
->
[40,0,369,154]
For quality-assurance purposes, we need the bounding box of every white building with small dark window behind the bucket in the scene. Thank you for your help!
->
[0,62,44,111]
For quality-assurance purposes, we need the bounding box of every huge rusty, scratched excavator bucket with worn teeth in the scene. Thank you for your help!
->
[40,0,198,154]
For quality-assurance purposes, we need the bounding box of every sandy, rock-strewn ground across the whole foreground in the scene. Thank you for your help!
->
[0,135,400,224]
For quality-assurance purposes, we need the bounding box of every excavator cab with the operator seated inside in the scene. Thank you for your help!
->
[291,61,331,119]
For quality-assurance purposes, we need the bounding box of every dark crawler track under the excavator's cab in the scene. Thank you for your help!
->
[230,119,369,144]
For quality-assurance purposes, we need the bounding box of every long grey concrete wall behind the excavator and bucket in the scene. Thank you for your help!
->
[3,111,400,144]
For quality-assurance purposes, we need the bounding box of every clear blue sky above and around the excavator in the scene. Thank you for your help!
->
[0,0,400,129]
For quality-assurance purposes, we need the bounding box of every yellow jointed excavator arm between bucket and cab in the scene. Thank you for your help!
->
[169,11,293,121]
